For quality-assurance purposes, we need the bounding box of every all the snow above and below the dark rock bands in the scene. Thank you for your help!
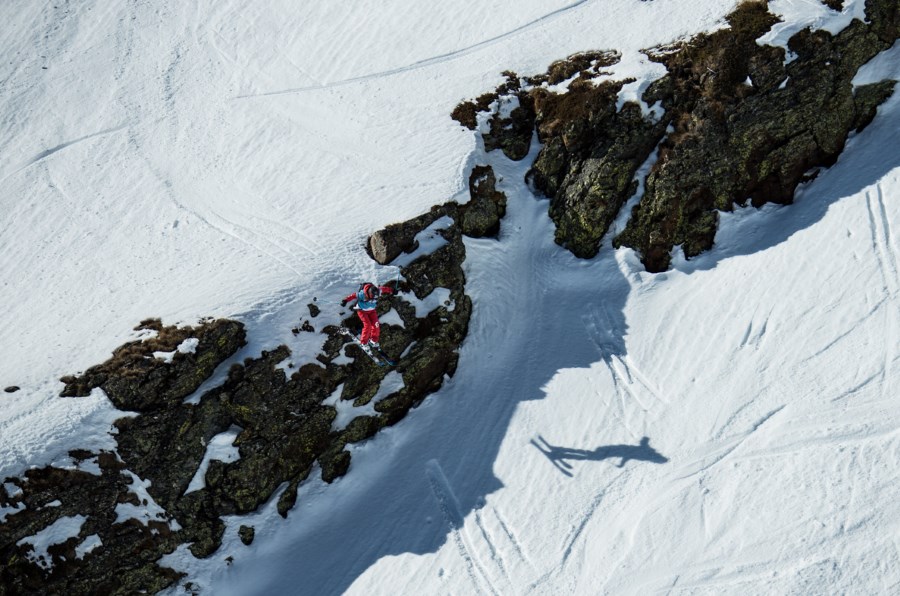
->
[0,0,900,594]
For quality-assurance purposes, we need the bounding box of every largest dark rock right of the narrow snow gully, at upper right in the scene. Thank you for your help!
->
[615,0,900,271]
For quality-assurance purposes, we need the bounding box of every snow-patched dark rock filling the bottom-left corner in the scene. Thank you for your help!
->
[0,453,186,594]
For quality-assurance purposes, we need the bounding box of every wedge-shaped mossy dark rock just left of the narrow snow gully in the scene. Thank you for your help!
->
[463,52,668,257]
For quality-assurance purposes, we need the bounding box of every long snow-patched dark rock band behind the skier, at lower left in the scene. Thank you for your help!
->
[0,167,506,594]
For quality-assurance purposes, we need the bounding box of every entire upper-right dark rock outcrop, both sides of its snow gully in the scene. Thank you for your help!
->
[454,0,900,271]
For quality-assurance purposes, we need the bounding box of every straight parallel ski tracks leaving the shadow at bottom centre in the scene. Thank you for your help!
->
[425,459,531,596]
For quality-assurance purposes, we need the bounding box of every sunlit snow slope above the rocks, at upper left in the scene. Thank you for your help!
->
[0,0,733,494]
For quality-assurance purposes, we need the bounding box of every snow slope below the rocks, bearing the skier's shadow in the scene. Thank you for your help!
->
[175,82,900,594]
